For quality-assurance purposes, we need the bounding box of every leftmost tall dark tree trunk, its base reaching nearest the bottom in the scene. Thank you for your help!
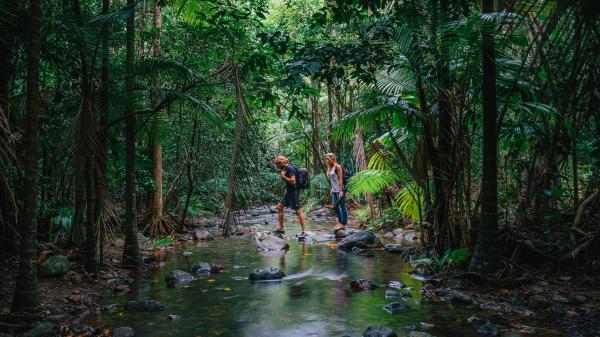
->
[12,0,42,312]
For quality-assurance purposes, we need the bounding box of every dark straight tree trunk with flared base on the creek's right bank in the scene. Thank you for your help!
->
[470,0,499,272]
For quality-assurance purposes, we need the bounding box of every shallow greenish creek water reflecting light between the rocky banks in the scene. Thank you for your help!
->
[96,209,558,337]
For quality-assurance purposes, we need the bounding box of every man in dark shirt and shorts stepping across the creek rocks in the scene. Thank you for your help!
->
[275,156,306,237]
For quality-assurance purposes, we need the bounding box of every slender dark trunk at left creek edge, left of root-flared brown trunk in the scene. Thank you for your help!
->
[122,0,142,267]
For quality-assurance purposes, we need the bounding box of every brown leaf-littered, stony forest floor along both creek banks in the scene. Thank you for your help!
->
[0,203,600,337]
